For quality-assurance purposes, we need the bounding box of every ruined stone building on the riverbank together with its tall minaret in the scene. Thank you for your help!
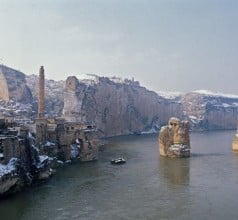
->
[36,67,98,161]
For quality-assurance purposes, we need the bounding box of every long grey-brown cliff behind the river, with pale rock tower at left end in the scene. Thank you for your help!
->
[64,76,183,136]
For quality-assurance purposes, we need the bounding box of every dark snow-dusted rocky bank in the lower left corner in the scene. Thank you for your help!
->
[0,119,52,198]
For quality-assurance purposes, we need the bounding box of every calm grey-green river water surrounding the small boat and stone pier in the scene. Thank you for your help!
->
[0,131,238,220]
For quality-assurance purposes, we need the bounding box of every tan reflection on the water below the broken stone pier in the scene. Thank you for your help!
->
[159,157,190,185]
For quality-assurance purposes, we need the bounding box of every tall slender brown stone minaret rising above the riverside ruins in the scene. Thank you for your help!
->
[38,66,45,118]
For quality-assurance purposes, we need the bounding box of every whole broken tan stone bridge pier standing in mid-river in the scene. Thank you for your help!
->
[159,118,190,157]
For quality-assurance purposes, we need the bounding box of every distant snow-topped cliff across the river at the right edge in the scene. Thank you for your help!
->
[181,90,238,130]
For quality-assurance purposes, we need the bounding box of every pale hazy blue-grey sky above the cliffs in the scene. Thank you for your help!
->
[0,0,238,94]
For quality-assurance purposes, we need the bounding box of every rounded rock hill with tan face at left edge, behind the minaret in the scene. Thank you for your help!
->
[0,65,32,103]
